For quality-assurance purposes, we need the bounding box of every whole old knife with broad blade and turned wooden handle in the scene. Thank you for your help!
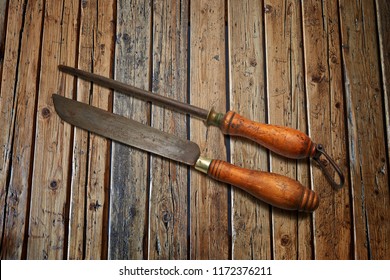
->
[53,94,319,212]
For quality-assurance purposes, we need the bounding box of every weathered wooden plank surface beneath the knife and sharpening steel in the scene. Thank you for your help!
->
[0,0,390,259]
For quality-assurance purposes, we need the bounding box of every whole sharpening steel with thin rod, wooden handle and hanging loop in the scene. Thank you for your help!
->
[58,65,344,189]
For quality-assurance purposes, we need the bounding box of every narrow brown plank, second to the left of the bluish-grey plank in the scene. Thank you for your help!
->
[65,1,97,260]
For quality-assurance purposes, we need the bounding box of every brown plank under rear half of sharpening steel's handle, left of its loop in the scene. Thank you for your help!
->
[264,1,313,259]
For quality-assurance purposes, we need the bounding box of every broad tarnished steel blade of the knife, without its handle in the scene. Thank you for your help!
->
[53,94,200,165]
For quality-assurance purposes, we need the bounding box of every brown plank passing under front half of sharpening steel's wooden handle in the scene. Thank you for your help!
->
[228,0,271,259]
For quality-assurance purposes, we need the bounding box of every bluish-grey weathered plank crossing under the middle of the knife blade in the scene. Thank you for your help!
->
[108,1,152,259]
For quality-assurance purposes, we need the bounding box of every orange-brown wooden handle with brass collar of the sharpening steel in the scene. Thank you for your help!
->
[207,109,316,159]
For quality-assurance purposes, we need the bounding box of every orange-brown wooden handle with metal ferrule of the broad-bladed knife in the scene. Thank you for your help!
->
[195,157,319,212]
